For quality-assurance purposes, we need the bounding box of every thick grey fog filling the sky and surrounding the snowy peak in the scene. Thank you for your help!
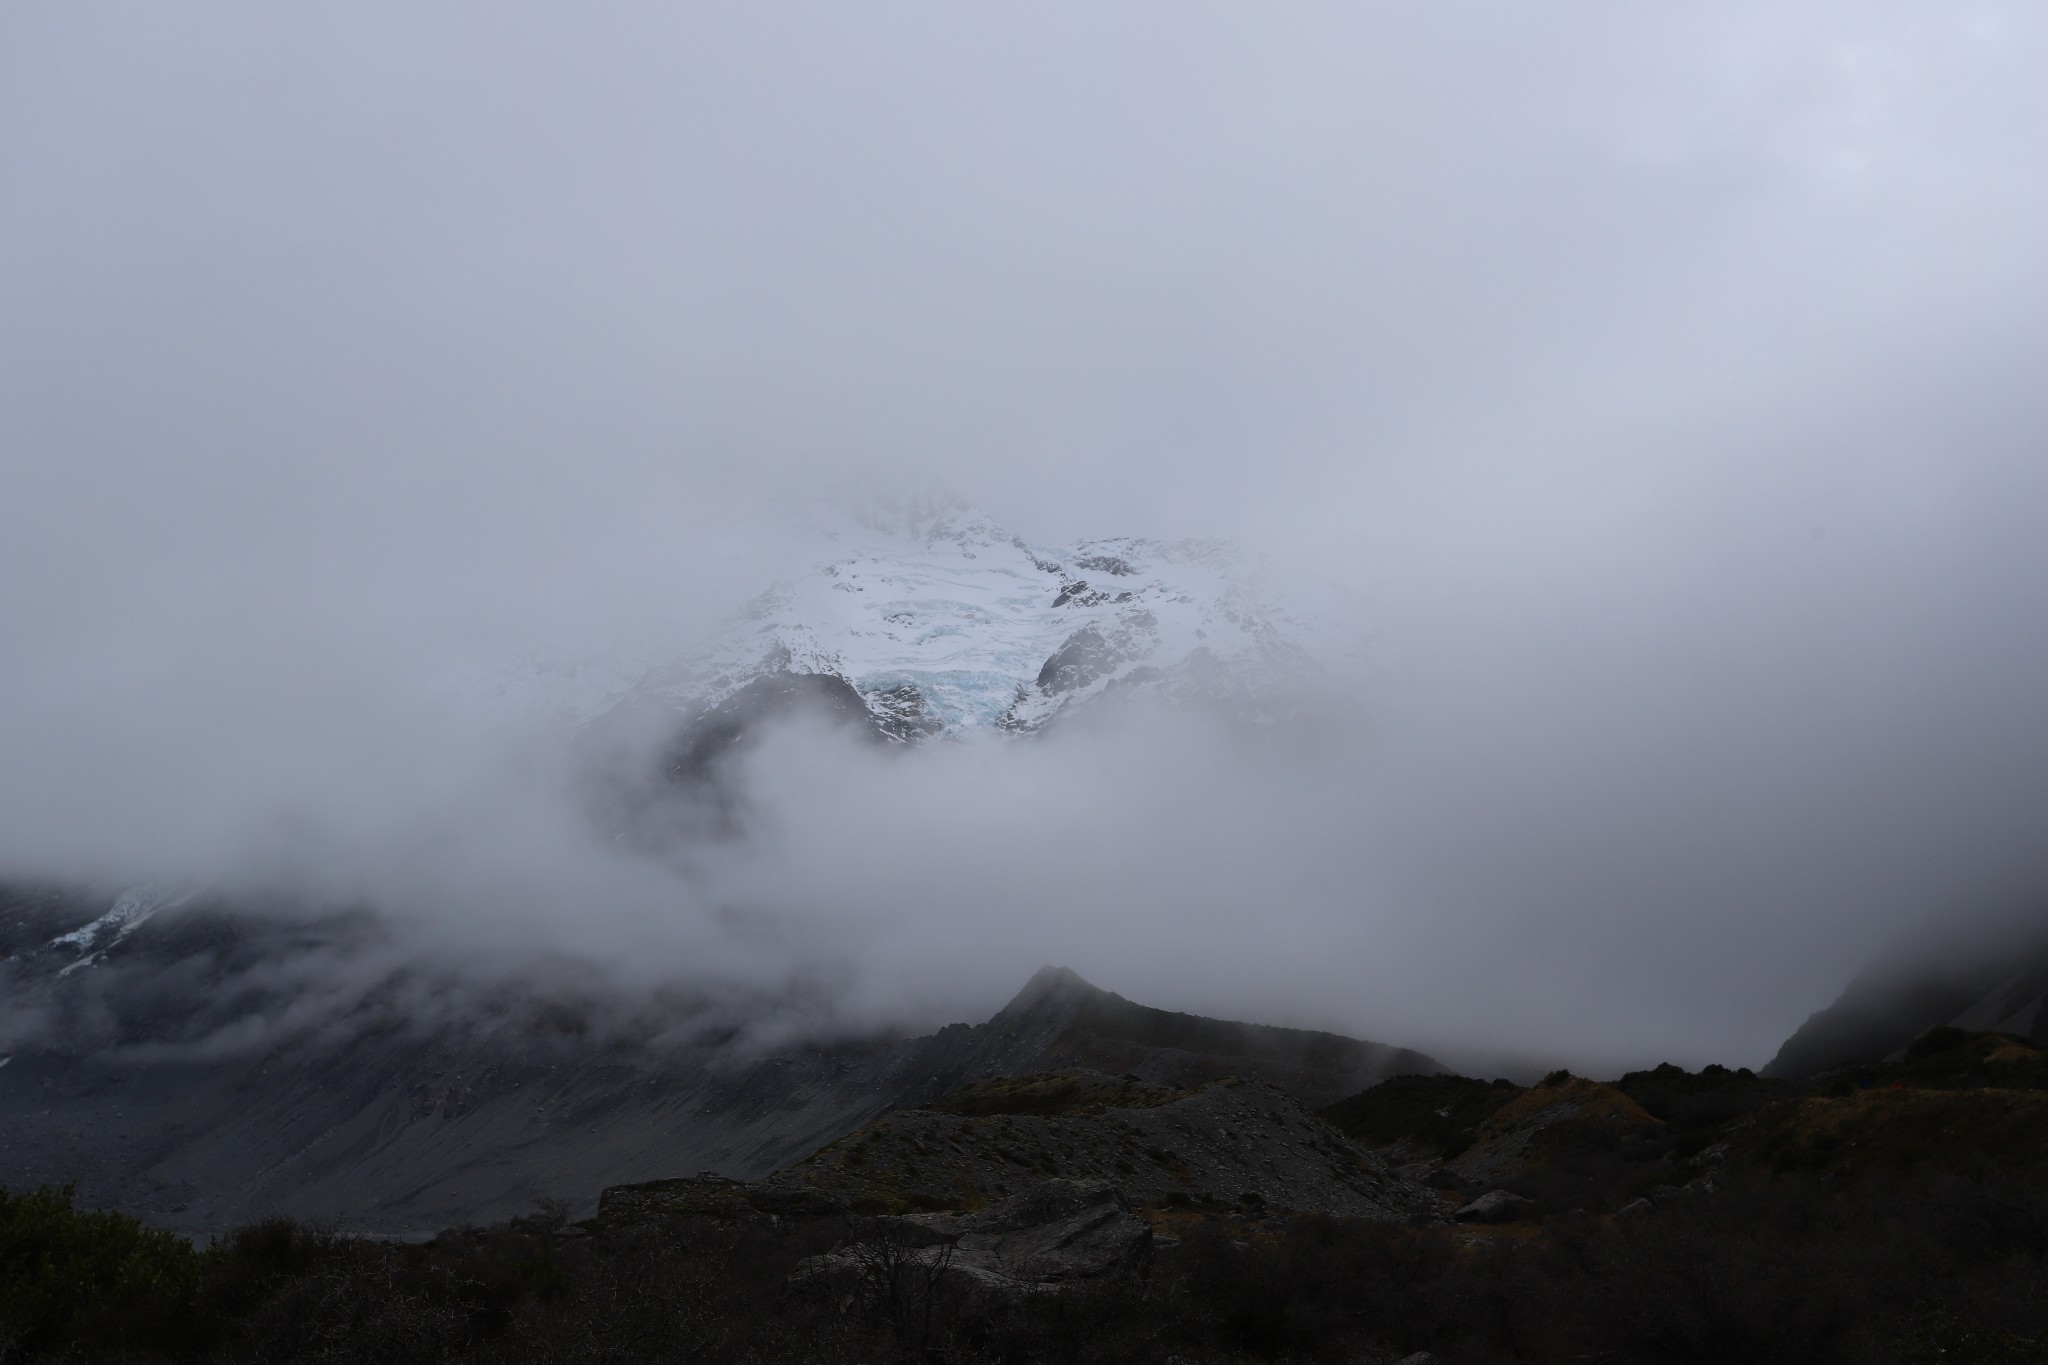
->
[0,2,2048,1066]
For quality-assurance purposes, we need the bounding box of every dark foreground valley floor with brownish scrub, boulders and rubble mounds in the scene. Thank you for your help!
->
[12,1029,2048,1365]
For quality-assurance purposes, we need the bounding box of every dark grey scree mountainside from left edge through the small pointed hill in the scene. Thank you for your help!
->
[0,892,1434,1232]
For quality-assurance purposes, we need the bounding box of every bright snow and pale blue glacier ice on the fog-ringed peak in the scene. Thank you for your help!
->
[627,493,1317,741]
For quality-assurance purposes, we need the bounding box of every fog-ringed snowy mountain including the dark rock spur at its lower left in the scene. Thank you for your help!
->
[581,487,1362,847]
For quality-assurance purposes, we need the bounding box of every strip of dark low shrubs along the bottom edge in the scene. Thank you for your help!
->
[0,1177,2048,1365]
